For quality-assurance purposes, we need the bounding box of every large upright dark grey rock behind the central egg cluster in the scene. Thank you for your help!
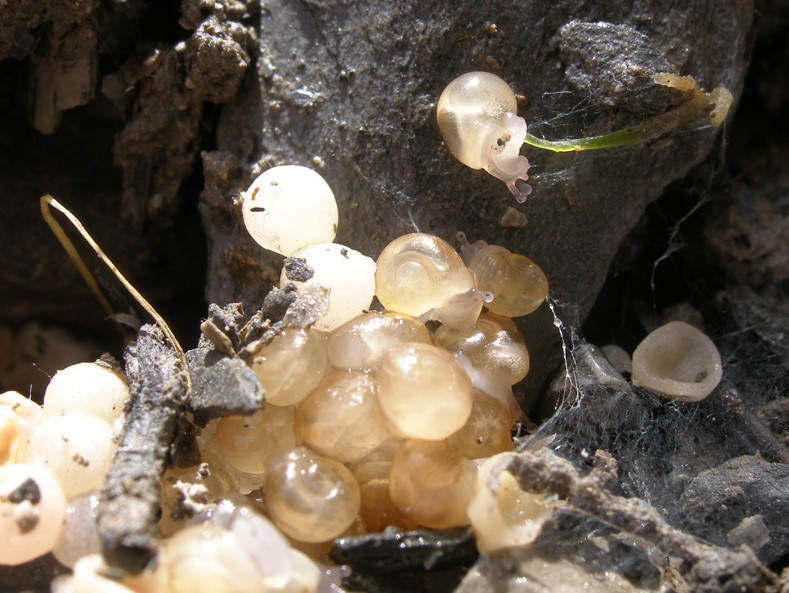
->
[201,0,751,393]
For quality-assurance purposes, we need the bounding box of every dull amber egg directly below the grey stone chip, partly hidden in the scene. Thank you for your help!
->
[216,404,296,474]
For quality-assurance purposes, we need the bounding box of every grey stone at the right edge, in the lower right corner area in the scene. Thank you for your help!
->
[679,455,789,563]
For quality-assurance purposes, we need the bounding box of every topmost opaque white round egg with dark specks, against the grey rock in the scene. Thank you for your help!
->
[243,165,338,257]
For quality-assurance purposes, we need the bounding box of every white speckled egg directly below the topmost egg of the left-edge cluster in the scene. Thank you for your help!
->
[25,412,115,499]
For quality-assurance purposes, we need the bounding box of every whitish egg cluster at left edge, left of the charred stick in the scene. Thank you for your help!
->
[0,362,129,566]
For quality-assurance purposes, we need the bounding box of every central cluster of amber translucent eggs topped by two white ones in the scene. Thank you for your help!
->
[198,167,547,544]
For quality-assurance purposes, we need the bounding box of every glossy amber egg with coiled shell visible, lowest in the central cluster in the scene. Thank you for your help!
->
[263,447,361,543]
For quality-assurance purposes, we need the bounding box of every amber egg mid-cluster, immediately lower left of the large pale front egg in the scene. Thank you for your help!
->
[295,371,389,462]
